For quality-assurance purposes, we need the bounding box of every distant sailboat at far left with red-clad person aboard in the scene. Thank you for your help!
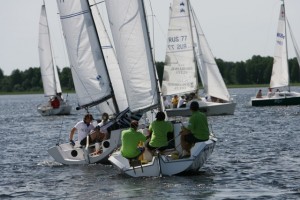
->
[37,5,72,116]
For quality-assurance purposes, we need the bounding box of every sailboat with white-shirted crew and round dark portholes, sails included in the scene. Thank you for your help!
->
[48,0,135,165]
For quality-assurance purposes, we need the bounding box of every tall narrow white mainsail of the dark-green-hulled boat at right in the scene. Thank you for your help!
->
[270,4,289,88]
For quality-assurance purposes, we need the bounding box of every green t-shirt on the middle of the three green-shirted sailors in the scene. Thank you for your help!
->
[149,120,173,147]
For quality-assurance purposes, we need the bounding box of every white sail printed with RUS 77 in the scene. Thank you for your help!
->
[162,0,198,95]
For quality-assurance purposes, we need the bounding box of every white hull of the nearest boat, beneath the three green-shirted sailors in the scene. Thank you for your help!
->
[108,123,217,177]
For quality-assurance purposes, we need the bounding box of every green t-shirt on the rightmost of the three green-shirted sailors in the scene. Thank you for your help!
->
[187,111,209,140]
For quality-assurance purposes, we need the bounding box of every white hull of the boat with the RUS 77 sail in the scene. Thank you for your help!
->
[166,101,236,117]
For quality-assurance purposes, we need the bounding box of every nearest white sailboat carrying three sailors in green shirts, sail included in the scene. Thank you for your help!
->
[106,0,216,177]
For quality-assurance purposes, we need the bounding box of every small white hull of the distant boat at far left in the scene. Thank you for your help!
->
[37,102,72,116]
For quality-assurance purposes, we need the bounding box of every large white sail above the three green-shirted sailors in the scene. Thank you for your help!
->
[105,0,158,112]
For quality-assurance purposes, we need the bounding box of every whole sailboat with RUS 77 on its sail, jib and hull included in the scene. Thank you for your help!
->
[162,0,236,117]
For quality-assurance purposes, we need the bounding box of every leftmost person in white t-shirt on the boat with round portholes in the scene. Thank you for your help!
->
[69,113,94,146]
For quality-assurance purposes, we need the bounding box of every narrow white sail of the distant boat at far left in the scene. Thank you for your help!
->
[39,5,61,96]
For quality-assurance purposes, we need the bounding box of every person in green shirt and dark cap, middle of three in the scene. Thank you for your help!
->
[146,112,173,151]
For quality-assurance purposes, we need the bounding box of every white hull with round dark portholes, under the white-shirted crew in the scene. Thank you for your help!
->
[48,129,122,165]
